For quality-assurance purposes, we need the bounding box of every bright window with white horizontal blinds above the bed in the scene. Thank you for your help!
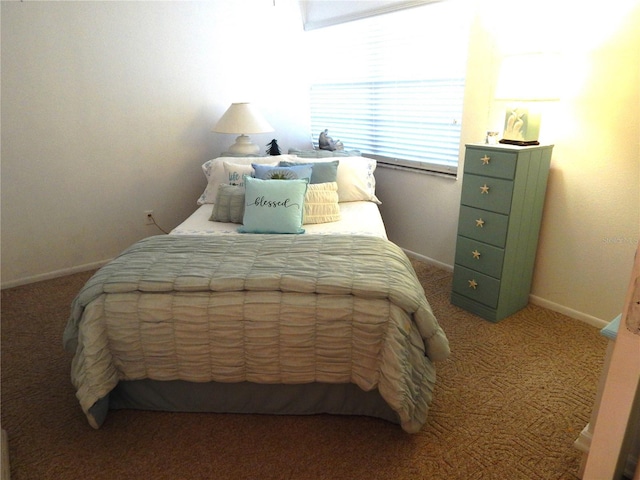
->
[305,0,469,174]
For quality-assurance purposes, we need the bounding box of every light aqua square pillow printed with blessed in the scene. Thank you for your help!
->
[238,177,308,233]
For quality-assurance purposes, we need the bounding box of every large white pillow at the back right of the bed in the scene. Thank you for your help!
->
[272,157,382,204]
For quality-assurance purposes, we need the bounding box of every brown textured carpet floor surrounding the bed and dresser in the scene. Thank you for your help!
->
[1,262,606,480]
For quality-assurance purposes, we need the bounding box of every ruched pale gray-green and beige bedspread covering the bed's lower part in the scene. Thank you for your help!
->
[64,235,449,432]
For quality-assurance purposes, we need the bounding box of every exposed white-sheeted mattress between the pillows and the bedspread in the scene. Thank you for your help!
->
[171,201,387,239]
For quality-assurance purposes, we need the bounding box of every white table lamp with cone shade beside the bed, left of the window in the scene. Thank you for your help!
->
[213,102,273,155]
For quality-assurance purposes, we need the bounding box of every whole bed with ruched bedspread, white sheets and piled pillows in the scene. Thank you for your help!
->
[63,155,449,433]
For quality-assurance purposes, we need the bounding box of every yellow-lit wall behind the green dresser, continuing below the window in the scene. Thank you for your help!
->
[376,0,640,325]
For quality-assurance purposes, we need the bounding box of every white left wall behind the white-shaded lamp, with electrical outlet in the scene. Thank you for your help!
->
[1,0,309,285]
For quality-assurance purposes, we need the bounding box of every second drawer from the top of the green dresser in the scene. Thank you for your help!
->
[461,175,513,214]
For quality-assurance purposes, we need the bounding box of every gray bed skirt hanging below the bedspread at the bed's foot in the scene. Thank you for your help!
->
[90,380,400,425]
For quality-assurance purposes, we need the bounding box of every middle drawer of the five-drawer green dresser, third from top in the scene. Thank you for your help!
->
[458,205,509,248]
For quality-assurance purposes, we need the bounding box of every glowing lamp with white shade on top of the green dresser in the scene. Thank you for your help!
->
[495,53,559,145]
